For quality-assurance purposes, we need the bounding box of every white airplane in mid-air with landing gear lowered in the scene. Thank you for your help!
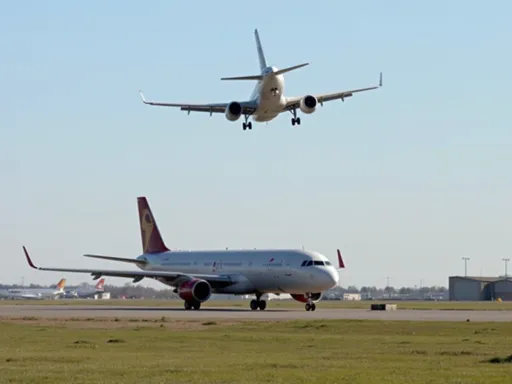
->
[139,29,382,130]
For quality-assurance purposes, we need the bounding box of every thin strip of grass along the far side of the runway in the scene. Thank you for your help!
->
[0,299,512,311]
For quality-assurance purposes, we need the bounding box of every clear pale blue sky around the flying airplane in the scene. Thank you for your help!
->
[0,1,512,287]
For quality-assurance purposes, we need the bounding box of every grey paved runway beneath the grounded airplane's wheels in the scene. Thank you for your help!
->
[0,305,512,322]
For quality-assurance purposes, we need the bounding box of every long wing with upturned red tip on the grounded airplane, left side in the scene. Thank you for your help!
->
[23,247,234,288]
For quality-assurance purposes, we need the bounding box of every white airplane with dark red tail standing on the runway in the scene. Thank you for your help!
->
[23,197,345,311]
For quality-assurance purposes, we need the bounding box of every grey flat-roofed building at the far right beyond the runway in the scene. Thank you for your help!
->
[449,276,512,301]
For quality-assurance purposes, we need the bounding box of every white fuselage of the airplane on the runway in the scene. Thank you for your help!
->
[137,249,339,294]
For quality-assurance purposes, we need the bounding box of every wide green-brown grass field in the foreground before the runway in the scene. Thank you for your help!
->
[0,318,512,384]
